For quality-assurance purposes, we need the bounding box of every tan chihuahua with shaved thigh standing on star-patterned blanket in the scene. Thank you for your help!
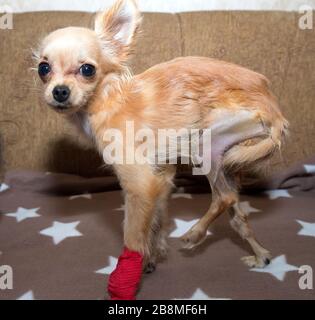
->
[37,0,288,271]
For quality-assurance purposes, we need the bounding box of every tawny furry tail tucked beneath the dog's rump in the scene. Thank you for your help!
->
[223,114,288,167]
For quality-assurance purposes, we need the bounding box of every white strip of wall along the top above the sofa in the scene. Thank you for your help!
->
[0,0,315,13]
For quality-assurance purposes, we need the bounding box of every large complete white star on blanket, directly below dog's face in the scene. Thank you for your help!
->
[39,221,82,245]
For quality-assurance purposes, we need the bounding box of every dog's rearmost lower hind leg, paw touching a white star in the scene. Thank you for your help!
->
[230,202,271,268]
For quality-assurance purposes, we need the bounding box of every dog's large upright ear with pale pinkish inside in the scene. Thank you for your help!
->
[94,0,141,62]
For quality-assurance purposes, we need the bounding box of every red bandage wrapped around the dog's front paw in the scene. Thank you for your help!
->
[108,248,143,300]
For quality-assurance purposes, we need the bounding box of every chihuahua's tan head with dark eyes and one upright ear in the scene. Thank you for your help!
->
[36,0,141,113]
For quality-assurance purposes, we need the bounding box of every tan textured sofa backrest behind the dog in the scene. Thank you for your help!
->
[0,12,315,175]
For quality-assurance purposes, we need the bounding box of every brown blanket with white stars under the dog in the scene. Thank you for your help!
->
[0,158,315,299]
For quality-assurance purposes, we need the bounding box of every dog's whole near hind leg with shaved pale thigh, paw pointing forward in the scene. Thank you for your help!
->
[182,110,265,249]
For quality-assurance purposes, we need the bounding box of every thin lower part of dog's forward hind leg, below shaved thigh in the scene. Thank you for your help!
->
[181,170,238,249]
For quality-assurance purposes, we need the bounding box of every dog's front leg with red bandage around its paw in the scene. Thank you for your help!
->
[108,165,165,299]
